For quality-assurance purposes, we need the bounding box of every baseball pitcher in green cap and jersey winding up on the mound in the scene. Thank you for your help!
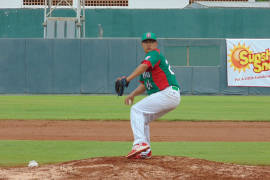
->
[115,32,180,159]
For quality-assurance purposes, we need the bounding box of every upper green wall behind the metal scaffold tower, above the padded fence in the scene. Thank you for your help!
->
[0,8,270,38]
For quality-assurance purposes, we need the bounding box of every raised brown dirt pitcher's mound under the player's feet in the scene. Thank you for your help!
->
[0,156,270,180]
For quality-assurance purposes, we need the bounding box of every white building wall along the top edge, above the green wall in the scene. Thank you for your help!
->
[0,0,189,9]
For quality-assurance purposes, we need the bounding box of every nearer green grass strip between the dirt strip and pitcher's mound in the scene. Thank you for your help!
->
[0,140,270,166]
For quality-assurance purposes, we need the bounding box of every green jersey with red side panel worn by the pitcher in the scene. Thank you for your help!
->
[140,49,180,95]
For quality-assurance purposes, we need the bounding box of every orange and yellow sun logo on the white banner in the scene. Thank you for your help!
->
[228,43,252,73]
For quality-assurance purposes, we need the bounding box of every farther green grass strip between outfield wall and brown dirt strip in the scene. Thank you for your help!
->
[0,95,270,121]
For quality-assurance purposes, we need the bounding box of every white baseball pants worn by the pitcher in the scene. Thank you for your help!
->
[130,86,180,146]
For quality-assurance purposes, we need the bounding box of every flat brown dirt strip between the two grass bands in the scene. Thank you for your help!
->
[0,120,270,142]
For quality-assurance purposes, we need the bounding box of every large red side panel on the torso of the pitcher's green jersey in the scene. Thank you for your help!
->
[152,60,169,90]
